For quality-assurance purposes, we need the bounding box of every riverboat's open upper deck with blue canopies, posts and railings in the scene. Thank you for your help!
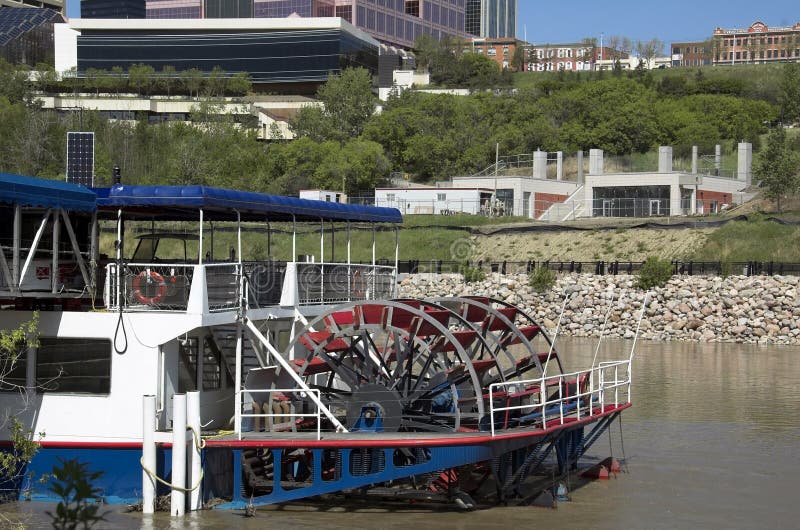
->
[0,176,402,314]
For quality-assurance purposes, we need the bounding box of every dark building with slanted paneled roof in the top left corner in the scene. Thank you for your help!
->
[0,7,64,66]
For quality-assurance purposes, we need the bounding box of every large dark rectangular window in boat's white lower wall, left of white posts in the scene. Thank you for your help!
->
[36,337,111,394]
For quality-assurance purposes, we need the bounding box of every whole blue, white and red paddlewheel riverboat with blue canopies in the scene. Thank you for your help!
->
[0,174,631,514]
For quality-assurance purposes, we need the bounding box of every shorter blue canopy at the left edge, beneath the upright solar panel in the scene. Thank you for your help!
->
[0,173,97,212]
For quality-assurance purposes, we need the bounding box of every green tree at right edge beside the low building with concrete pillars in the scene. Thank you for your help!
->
[753,127,800,212]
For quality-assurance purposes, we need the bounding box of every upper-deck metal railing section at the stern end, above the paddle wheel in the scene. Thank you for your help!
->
[297,263,395,305]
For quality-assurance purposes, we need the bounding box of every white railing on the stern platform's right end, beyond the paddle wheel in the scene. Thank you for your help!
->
[489,360,631,436]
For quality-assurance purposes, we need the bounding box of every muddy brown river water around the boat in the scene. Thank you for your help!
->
[0,339,800,529]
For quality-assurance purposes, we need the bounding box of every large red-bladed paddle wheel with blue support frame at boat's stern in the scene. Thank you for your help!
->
[227,297,632,507]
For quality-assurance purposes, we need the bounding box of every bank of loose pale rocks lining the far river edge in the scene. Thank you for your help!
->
[400,273,800,344]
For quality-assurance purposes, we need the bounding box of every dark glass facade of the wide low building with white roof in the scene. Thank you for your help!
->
[78,28,378,83]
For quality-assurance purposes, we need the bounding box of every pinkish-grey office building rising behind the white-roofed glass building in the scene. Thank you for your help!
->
[147,0,468,48]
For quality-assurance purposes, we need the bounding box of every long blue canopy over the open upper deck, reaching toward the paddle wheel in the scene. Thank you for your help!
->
[96,184,403,223]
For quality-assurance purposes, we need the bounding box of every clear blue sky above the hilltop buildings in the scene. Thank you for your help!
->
[67,0,800,44]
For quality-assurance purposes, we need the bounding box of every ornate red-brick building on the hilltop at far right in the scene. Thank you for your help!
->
[712,22,800,66]
